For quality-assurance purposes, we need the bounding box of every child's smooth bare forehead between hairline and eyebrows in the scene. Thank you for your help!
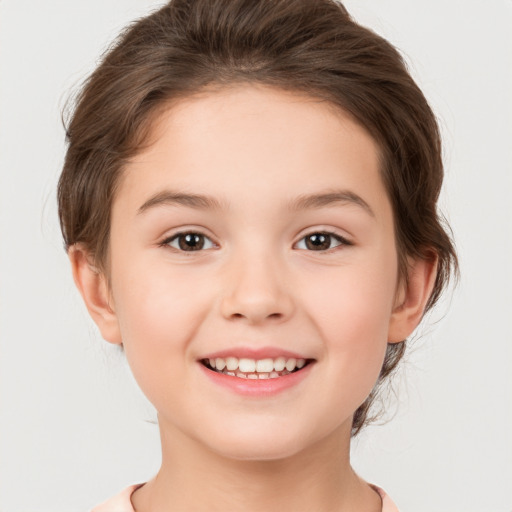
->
[116,85,386,223]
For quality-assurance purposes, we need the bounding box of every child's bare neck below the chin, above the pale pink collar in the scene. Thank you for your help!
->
[132,422,381,512]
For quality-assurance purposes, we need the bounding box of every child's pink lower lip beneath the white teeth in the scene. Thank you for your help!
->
[198,363,313,397]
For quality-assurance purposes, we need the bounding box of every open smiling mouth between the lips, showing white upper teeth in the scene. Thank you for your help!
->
[201,357,314,380]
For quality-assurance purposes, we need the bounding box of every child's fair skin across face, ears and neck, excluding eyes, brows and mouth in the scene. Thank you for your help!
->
[69,85,435,512]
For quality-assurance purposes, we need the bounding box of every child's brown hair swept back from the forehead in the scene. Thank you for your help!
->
[58,0,457,435]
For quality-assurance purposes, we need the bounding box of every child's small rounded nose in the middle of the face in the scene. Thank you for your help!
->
[221,248,294,325]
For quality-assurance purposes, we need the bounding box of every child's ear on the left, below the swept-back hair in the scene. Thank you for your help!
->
[68,244,122,345]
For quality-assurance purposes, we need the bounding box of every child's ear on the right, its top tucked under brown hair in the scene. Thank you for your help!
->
[388,252,438,343]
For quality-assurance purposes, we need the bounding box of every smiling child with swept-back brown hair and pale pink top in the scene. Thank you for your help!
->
[58,0,457,512]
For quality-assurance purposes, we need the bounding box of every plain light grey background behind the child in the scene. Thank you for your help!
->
[0,0,512,512]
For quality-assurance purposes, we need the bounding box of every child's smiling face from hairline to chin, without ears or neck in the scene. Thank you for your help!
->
[100,86,399,459]
